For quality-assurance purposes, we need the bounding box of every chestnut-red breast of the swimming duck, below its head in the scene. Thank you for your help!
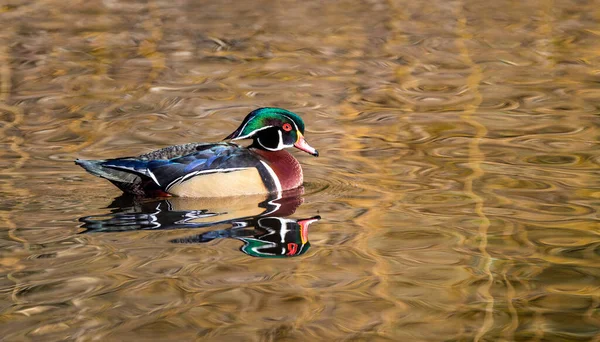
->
[252,148,304,190]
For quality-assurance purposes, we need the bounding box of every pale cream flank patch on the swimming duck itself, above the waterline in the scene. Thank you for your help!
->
[164,168,269,197]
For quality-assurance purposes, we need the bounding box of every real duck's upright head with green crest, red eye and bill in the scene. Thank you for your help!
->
[225,107,319,157]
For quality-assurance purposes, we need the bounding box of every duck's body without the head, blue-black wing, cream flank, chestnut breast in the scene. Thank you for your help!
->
[77,143,303,197]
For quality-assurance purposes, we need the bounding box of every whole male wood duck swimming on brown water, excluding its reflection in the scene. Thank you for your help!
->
[75,108,319,197]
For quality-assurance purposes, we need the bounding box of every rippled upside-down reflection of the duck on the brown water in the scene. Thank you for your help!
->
[79,192,320,258]
